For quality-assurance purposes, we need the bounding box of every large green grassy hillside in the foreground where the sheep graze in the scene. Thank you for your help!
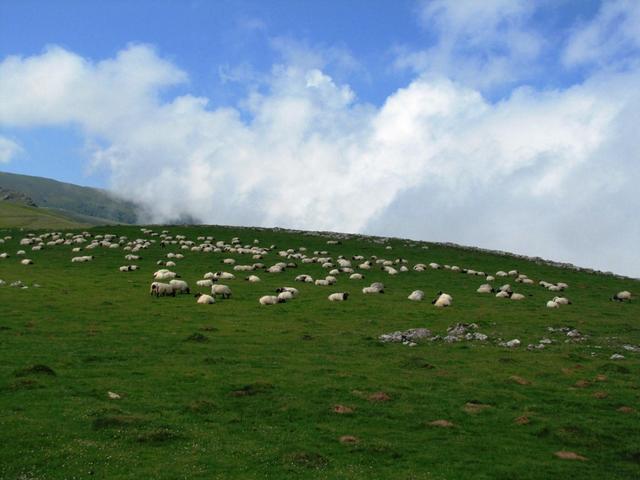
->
[0,226,640,479]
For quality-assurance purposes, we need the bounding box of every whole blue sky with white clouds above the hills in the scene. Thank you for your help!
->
[0,0,640,277]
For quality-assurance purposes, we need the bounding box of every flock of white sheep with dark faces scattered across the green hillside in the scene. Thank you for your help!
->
[0,228,631,308]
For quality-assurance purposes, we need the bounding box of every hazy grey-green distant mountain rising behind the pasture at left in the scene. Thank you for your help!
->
[0,172,137,225]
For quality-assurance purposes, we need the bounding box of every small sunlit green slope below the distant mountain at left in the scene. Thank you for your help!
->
[0,202,89,229]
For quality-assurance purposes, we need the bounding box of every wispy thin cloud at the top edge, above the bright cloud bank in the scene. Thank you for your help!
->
[395,0,545,90]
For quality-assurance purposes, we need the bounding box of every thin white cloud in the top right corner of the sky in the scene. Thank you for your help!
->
[563,0,640,67]
